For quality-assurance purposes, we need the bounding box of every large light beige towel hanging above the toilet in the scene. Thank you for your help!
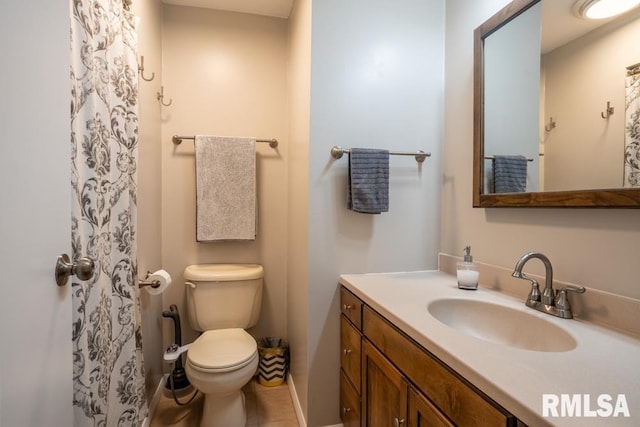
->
[195,135,256,242]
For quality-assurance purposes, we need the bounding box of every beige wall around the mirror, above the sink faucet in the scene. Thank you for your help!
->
[440,0,640,298]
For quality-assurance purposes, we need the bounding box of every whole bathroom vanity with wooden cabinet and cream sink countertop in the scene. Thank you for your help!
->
[340,271,640,427]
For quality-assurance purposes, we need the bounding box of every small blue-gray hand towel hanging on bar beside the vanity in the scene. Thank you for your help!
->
[347,148,389,214]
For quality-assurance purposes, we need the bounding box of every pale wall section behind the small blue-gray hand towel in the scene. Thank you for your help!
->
[307,0,442,427]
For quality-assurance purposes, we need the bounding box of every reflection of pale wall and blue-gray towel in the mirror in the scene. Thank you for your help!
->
[484,3,541,193]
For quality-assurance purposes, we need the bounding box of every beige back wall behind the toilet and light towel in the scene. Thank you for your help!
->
[160,5,288,350]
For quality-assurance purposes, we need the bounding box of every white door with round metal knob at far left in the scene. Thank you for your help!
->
[0,0,73,427]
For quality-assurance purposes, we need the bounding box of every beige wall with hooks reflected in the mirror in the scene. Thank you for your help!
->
[543,18,640,191]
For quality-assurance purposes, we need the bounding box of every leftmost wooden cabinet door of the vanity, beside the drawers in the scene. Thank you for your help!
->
[362,340,409,427]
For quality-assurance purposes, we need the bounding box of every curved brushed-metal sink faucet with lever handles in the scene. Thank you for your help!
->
[512,252,585,319]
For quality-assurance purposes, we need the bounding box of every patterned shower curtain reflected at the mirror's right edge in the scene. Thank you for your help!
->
[624,69,640,188]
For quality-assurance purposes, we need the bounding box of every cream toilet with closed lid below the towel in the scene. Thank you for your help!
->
[184,264,264,427]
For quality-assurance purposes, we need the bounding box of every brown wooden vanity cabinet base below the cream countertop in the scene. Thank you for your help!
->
[340,288,521,427]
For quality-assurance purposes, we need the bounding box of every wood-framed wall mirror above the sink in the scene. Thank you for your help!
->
[473,0,640,208]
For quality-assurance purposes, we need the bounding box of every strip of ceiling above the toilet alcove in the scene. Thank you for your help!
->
[162,0,293,19]
